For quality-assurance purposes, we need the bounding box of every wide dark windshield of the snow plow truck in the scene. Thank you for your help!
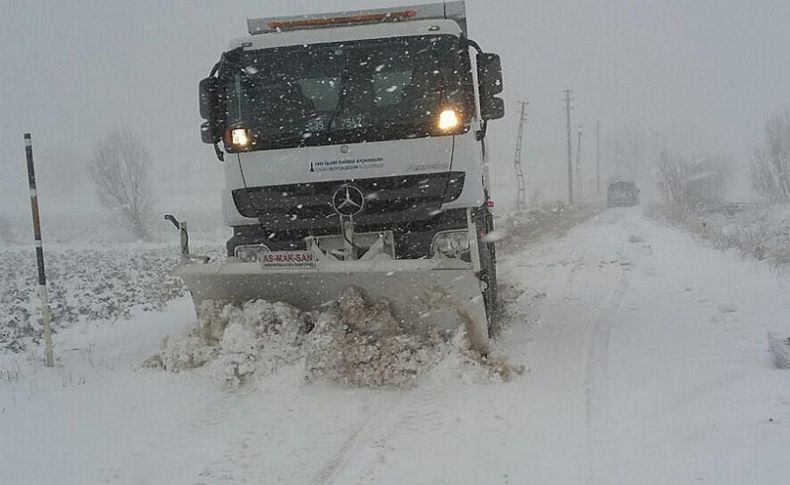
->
[220,35,474,150]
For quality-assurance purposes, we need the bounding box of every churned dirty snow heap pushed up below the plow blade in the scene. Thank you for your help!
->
[148,287,474,389]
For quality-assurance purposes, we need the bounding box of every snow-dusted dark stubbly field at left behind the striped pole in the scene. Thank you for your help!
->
[0,244,220,351]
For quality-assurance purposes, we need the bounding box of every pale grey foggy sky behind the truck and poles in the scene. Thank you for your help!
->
[0,0,790,212]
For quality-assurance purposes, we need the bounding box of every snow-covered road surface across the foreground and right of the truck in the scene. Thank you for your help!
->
[0,209,790,485]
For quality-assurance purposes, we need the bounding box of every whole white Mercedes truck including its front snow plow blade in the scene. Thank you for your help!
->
[173,2,504,353]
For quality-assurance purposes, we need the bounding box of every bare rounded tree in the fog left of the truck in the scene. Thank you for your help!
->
[89,129,153,239]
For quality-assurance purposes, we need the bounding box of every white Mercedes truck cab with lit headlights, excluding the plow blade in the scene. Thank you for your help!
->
[200,2,504,258]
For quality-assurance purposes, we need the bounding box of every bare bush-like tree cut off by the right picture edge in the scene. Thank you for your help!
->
[750,111,790,202]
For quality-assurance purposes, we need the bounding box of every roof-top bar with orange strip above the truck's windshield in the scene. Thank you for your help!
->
[247,0,466,35]
